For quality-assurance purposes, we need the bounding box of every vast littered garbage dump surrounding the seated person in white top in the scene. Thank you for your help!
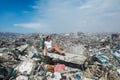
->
[0,33,120,80]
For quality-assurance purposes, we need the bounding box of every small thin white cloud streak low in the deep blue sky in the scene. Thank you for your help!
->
[14,23,42,29]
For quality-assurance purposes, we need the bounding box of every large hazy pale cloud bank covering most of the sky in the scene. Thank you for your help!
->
[14,0,120,32]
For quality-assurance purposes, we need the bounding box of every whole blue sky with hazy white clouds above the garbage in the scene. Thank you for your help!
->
[0,0,120,33]
